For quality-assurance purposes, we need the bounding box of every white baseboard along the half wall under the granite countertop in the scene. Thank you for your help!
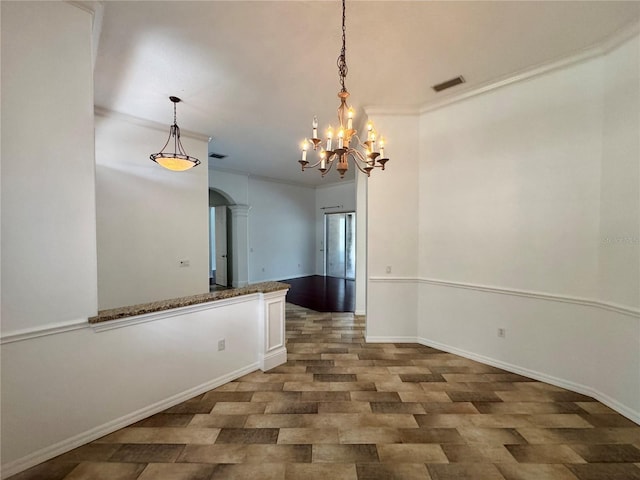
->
[0,362,260,479]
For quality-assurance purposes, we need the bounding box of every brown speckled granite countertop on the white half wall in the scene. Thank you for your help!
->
[89,282,290,323]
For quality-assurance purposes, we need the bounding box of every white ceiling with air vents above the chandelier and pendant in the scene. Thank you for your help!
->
[95,0,640,185]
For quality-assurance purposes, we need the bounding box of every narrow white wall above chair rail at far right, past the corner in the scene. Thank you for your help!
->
[599,37,640,307]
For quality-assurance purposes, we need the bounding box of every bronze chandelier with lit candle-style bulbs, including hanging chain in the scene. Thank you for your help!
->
[298,0,389,178]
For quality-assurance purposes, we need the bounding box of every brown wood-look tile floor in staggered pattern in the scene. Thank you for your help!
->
[12,305,640,480]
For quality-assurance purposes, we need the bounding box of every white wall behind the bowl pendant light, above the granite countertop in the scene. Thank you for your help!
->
[95,114,209,310]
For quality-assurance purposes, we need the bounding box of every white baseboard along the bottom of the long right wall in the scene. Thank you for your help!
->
[414,337,640,424]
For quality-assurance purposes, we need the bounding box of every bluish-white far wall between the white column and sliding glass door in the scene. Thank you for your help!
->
[248,177,315,283]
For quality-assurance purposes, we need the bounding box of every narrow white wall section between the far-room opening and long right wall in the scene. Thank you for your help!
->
[367,113,419,341]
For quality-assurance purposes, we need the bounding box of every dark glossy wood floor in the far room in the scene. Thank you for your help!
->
[282,275,356,312]
